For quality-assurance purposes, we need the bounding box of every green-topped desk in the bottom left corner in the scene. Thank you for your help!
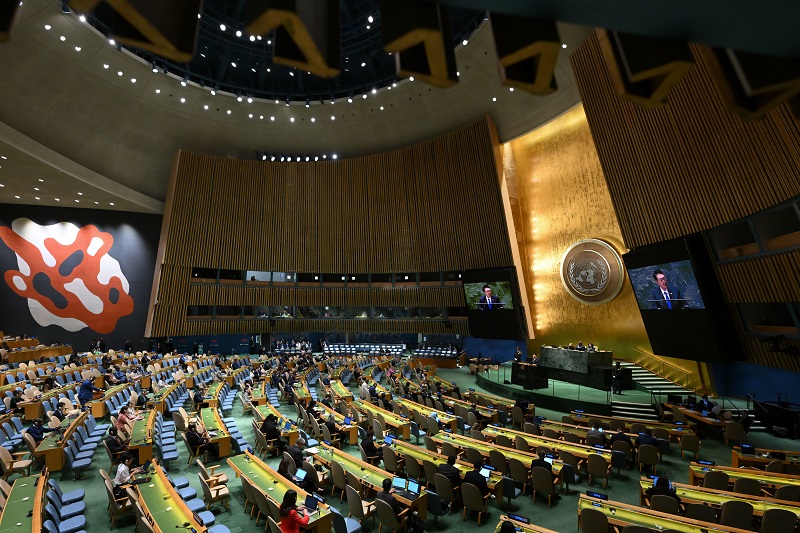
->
[0,473,47,533]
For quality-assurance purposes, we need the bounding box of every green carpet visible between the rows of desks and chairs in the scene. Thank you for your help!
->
[50,368,796,533]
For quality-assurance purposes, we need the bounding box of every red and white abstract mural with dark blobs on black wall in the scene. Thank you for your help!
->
[0,218,134,334]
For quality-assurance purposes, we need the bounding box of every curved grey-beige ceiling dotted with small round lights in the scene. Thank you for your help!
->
[0,0,589,212]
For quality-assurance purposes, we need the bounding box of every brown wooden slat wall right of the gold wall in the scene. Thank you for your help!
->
[571,35,800,370]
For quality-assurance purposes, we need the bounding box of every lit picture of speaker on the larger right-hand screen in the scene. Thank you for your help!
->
[628,260,706,311]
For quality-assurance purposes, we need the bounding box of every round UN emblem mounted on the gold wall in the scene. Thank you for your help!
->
[561,239,624,305]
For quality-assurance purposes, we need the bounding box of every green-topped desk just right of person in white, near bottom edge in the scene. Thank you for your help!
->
[135,462,206,533]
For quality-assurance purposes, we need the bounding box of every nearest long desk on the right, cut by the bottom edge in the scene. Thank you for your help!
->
[578,494,752,533]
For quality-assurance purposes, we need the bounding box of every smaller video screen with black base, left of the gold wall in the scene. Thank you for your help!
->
[462,268,522,339]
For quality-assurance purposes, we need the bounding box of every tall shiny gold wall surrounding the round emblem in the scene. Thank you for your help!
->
[504,106,708,385]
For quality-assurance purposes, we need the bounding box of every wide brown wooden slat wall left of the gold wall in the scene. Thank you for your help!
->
[150,120,506,336]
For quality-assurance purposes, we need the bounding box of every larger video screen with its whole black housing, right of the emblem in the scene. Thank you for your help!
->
[623,234,741,362]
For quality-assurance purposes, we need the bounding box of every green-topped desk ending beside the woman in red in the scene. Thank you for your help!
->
[228,452,333,533]
